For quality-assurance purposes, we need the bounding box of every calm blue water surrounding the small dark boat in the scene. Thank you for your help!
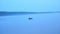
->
[0,13,60,34]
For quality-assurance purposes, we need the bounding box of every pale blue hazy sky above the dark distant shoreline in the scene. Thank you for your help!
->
[0,0,60,12]
